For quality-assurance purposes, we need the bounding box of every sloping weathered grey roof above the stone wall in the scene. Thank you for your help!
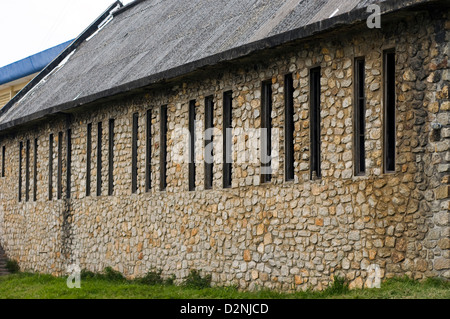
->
[0,0,436,129]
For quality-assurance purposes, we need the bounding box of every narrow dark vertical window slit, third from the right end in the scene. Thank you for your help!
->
[310,67,322,179]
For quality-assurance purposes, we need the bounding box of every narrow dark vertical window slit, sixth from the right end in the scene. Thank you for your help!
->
[223,91,233,188]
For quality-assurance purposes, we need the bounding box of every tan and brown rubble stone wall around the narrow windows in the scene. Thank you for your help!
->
[0,8,450,290]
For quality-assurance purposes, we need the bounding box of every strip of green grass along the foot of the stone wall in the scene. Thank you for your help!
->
[0,273,450,299]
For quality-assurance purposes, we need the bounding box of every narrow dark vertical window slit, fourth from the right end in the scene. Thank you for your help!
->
[284,73,294,181]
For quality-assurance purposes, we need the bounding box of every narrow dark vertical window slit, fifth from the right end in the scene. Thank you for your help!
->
[261,81,272,183]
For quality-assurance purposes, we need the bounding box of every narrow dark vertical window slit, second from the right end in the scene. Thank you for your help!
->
[354,58,366,175]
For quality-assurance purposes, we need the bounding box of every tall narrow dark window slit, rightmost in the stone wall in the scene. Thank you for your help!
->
[384,50,396,173]
